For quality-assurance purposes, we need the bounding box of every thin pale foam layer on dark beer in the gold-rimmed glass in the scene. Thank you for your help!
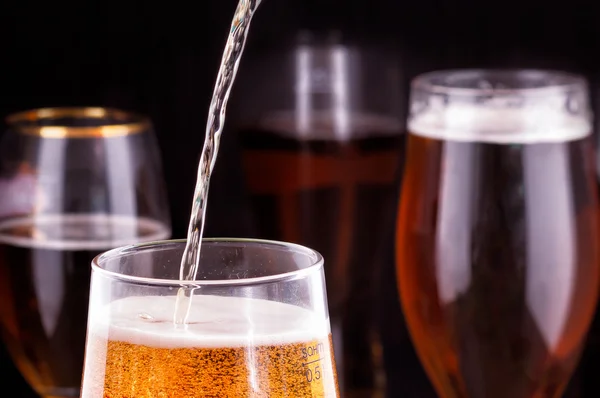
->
[0,214,171,250]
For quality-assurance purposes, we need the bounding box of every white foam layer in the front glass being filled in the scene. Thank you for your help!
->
[90,295,330,348]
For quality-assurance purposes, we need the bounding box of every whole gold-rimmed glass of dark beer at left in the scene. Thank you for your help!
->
[0,108,170,397]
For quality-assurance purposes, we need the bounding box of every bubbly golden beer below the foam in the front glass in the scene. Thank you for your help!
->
[82,333,339,398]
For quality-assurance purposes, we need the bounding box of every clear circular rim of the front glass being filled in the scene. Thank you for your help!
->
[92,238,324,288]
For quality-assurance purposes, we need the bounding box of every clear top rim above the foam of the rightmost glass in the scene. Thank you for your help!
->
[411,68,588,97]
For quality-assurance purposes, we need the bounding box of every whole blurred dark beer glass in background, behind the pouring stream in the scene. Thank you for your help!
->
[232,31,404,397]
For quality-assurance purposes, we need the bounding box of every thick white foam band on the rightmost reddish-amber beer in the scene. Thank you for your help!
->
[408,103,592,144]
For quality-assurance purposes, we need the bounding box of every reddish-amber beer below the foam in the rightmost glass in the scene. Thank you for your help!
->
[397,134,599,398]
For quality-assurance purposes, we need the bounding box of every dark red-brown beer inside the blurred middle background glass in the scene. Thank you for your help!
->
[241,115,404,397]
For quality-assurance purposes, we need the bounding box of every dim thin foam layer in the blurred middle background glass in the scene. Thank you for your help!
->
[259,110,404,141]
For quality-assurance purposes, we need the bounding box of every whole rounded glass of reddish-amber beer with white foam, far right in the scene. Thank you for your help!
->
[397,70,599,398]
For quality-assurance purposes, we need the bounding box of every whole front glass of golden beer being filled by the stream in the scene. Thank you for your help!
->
[81,239,338,398]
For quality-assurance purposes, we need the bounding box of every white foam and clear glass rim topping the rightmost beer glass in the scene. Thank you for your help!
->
[408,69,592,144]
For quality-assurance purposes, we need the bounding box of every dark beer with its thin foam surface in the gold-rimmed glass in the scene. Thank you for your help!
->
[0,215,170,397]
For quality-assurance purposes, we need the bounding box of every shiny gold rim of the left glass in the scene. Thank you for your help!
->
[5,106,151,139]
